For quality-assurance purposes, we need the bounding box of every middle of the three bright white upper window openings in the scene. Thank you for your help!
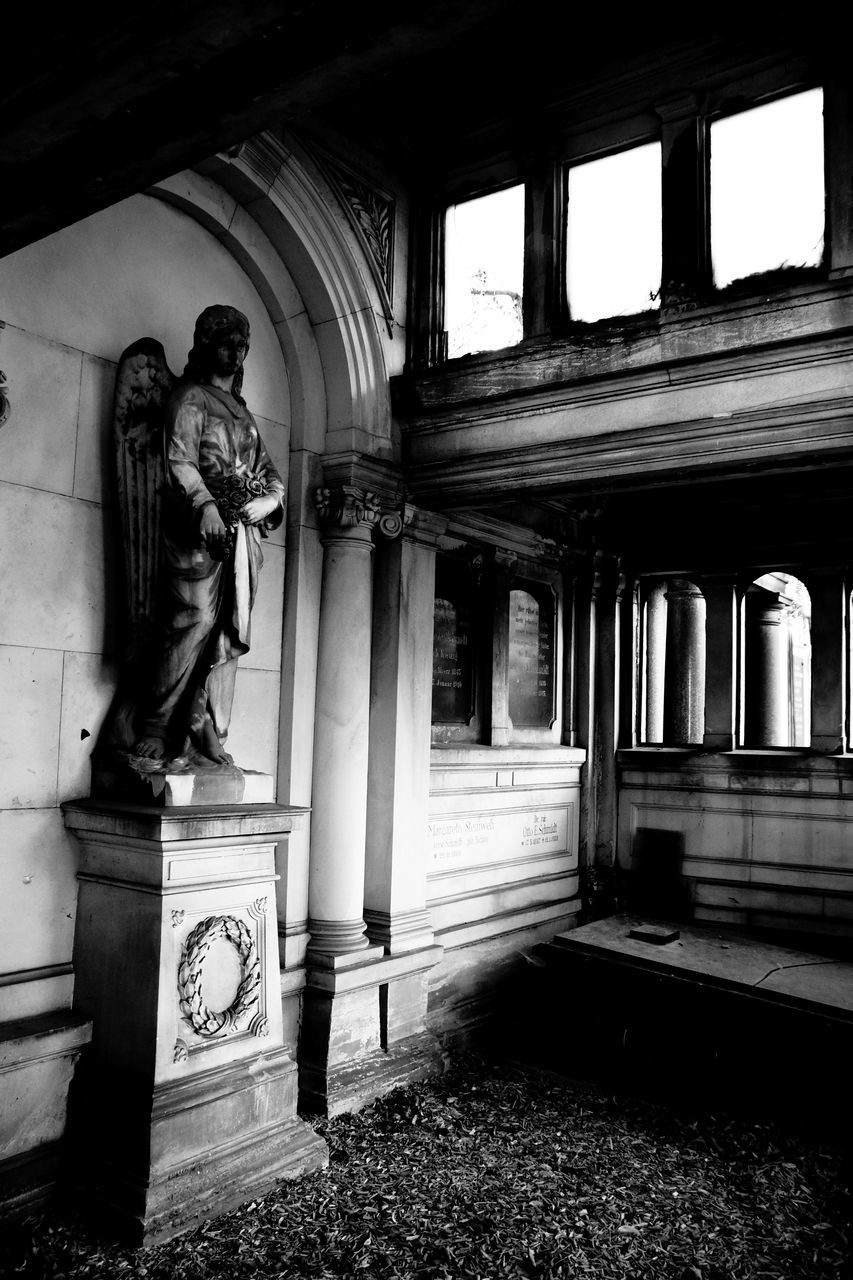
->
[566,142,661,321]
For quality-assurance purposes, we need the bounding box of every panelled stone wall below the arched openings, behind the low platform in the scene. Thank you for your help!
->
[619,751,853,938]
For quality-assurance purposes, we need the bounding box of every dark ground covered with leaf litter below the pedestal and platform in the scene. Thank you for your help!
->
[0,1057,850,1280]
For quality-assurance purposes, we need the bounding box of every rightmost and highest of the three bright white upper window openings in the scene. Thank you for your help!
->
[711,88,825,288]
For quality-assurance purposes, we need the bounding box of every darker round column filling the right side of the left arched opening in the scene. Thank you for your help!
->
[663,579,704,746]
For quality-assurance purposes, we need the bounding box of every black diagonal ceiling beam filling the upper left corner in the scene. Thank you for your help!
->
[0,0,510,255]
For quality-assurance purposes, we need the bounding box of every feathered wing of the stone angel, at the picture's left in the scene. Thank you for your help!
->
[113,338,175,657]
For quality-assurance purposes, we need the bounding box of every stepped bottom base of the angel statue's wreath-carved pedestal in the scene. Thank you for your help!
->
[67,1051,328,1245]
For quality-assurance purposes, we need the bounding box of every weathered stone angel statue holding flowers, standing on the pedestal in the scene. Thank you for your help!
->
[99,305,284,773]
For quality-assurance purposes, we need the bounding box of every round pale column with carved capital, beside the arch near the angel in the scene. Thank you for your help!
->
[302,485,379,961]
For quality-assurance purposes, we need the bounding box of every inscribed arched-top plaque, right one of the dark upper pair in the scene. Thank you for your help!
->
[508,582,556,728]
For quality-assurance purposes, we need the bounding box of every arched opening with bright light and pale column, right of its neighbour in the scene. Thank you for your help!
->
[744,573,812,746]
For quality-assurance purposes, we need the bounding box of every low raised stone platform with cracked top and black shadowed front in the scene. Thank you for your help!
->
[530,915,853,1139]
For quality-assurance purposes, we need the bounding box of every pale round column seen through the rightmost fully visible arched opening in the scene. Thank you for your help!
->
[744,586,790,746]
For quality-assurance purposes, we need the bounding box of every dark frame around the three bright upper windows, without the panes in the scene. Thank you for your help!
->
[409,58,824,375]
